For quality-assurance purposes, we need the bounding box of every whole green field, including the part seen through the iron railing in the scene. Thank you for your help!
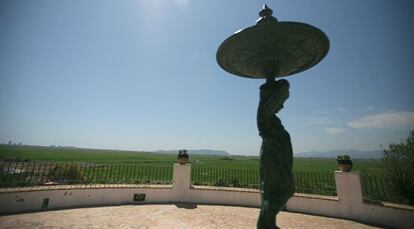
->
[0,145,393,200]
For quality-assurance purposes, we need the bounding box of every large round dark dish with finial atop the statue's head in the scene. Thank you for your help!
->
[216,5,329,79]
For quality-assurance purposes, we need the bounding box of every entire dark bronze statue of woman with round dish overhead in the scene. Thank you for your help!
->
[216,5,329,229]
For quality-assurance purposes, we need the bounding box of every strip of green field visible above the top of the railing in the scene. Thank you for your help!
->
[0,145,381,175]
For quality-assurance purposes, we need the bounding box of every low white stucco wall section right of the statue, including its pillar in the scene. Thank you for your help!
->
[287,171,414,228]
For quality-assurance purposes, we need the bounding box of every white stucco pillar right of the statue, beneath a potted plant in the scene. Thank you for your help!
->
[335,171,363,219]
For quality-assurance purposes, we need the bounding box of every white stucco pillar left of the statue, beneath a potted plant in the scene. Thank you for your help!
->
[173,163,191,202]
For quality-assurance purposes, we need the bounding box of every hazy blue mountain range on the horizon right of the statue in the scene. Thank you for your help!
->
[294,149,383,159]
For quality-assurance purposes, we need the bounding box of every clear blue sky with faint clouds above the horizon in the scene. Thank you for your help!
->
[0,0,414,155]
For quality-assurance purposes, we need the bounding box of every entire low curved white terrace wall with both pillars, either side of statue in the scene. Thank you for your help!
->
[0,164,414,228]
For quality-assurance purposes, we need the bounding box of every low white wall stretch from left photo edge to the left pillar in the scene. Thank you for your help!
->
[0,187,173,214]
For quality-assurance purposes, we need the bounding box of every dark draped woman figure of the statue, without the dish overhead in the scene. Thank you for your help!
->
[257,78,295,229]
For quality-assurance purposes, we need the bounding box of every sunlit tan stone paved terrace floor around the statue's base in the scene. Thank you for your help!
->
[0,204,378,229]
